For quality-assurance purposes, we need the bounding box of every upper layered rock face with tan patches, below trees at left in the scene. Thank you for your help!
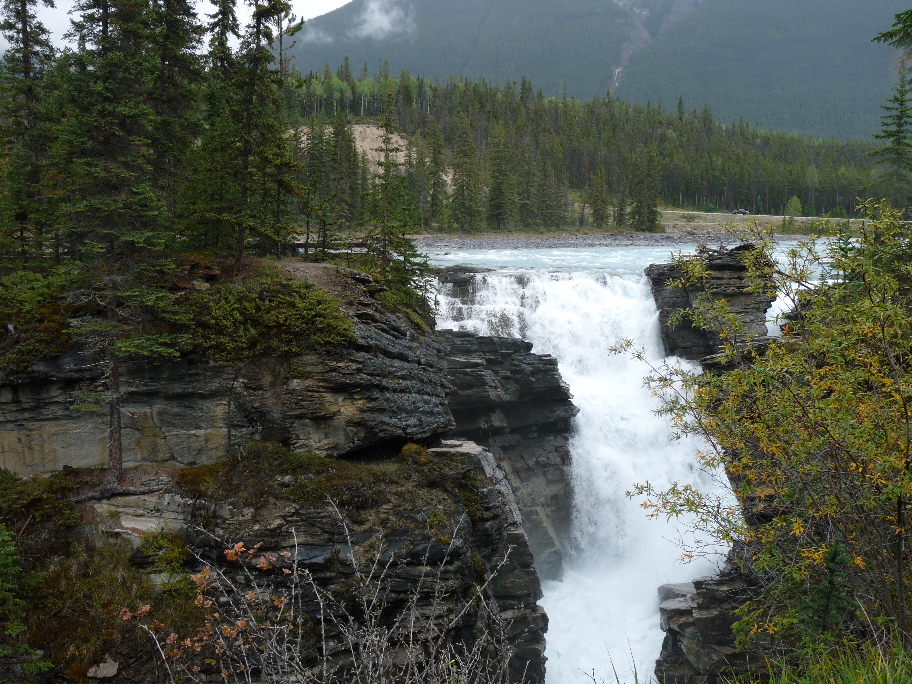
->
[0,264,454,475]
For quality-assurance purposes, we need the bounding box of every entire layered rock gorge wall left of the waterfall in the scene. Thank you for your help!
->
[0,262,575,682]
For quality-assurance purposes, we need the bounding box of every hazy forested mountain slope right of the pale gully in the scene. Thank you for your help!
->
[616,0,908,139]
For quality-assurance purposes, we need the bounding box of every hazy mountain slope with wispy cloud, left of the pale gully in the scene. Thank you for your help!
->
[293,0,636,96]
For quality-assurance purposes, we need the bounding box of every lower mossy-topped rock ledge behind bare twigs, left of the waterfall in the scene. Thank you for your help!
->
[101,441,548,684]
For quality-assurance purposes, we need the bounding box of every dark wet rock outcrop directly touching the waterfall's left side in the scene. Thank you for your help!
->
[441,324,578,579]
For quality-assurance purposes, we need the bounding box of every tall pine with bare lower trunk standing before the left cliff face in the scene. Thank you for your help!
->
[57,0,177,496]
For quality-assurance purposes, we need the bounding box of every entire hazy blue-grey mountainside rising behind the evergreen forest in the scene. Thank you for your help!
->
[292,0,906,139]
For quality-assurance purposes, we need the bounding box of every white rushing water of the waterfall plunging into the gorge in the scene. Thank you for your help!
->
[433,247,728,684]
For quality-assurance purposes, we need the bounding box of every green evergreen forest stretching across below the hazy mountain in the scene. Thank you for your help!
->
[0,0,874,272]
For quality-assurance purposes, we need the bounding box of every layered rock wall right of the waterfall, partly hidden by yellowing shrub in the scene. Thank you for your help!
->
[646,245,773,684]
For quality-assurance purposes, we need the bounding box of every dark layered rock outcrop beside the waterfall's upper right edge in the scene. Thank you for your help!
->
[646,245,774,361]
